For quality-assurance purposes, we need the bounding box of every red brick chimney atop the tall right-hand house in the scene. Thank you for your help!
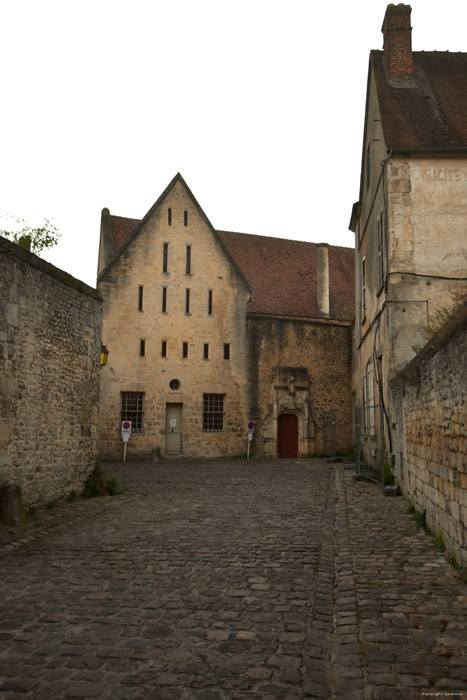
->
[381,3,413,87]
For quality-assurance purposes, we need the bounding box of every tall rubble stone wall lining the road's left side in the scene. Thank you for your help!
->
[0,238,101,505]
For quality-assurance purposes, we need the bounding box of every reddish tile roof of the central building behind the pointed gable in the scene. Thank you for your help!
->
[110,215,354,320]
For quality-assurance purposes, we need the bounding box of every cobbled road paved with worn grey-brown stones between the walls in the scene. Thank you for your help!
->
[0,459,467,700]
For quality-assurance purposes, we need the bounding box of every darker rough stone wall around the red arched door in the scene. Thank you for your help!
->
[247,315,352,457]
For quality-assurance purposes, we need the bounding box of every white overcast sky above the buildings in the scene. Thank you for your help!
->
[0,0,467,286]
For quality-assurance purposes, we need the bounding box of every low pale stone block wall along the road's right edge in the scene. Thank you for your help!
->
[392,303,467,566]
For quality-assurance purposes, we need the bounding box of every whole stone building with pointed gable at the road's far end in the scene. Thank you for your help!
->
[97,175,354,458]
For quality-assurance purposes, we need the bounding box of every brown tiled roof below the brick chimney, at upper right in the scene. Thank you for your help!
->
[370,51,467,149]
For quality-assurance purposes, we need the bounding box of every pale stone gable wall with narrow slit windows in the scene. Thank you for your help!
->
[98,181,249,459]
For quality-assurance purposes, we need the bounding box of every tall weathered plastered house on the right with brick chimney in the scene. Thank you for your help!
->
[350,4,467,461]
